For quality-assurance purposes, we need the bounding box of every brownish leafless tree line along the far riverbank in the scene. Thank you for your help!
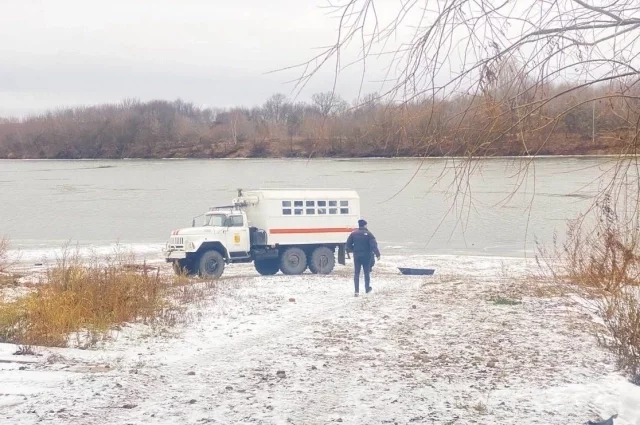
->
[0,84,640,159]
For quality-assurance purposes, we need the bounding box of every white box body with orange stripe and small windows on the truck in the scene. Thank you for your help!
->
[234,189,360,245]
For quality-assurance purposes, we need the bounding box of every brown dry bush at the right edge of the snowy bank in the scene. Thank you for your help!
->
[537,200,640,385]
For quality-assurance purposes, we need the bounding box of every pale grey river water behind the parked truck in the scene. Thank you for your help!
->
[0,158,612,256]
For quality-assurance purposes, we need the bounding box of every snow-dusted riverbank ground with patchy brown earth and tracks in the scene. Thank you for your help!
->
[0,256,640,425]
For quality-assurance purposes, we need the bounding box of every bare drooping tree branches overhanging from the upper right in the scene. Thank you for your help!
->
[287,0,640,215]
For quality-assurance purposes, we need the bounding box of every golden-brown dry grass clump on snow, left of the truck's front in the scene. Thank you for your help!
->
[0,243,218,347]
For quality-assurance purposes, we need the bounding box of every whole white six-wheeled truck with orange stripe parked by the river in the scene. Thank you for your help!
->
[164,189,360,278]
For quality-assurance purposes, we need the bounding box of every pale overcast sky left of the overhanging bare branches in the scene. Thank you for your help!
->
[0,0,396,116]
